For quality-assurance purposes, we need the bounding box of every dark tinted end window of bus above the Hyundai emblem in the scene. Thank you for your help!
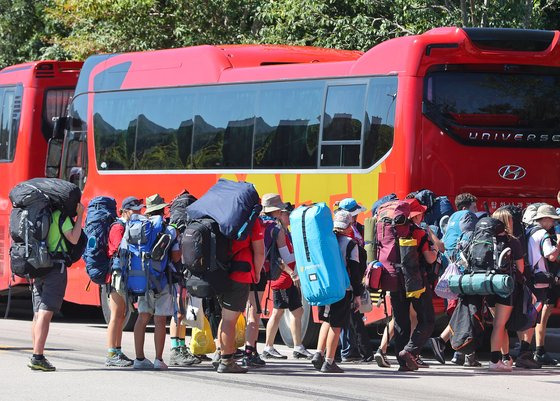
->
[424,66,560,147]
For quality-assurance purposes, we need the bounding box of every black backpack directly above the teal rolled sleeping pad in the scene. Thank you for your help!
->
[467,217,513,274]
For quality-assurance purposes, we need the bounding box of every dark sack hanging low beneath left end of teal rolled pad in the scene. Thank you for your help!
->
[449,296,484,354]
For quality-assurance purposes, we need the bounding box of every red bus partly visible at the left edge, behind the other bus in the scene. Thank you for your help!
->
[0,61,82,300]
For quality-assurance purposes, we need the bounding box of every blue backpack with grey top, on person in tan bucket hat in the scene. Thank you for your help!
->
[119,214,170,295]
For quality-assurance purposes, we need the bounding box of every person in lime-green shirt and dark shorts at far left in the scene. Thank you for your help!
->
[28,203,85,372]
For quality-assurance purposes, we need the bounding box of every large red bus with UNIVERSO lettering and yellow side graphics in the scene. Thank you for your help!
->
[7,28,560,338]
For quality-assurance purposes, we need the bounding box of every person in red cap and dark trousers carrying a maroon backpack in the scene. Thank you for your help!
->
[391,199,438,372]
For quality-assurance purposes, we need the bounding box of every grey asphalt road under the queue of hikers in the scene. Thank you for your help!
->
[0,310,560,401]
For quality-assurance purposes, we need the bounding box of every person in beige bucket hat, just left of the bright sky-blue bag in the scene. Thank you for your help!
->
[261,194,313,359]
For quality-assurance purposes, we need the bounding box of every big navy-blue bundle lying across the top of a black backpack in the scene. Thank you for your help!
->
[187,178,262,240]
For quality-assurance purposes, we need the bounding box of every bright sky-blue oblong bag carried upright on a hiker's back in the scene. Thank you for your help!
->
[290,202,350,306]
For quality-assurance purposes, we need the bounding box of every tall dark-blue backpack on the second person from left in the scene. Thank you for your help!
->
[83,196,117,284]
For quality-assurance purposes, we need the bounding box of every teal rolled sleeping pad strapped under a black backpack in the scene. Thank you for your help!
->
[449,273,515,298]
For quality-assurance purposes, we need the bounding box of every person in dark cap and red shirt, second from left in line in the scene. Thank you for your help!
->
[105,196,144,367]
